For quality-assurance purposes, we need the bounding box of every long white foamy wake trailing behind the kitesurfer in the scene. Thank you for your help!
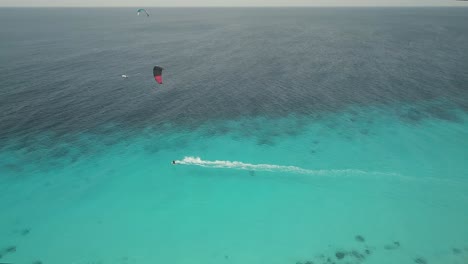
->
[175,157,401,177]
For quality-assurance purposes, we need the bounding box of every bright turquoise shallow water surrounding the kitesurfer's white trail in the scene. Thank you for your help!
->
[0,103,468,263]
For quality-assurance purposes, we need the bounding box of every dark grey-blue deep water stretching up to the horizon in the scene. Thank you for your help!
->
[0,8,468,138]
